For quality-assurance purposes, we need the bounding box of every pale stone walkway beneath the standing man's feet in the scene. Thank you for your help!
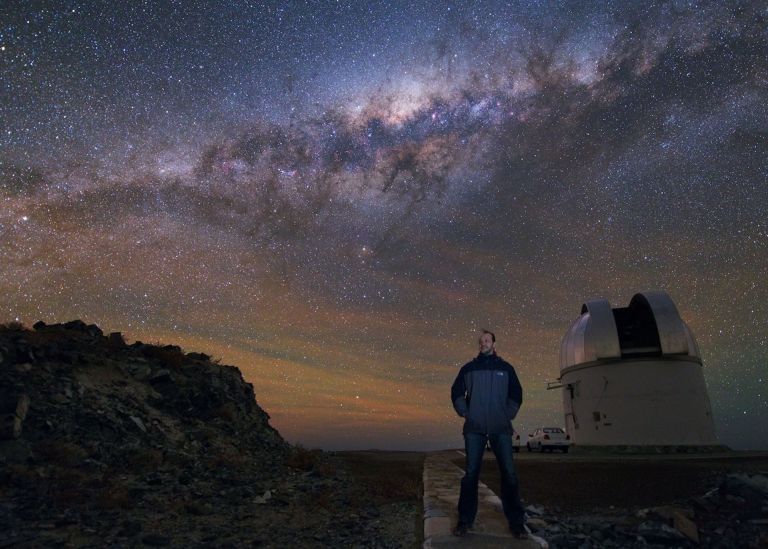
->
[424,450,548,549]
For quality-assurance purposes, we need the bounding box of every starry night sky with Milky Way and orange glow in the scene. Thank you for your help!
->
[0,1,768,449]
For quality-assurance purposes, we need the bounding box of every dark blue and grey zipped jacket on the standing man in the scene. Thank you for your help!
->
[451,353,523,434]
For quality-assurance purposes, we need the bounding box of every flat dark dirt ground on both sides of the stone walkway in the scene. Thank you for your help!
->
[320,451,768,546]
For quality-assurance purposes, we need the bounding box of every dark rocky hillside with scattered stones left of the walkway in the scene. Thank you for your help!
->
[0,320,418,547]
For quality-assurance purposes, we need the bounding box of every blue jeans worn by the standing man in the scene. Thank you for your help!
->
[459,433,525,527]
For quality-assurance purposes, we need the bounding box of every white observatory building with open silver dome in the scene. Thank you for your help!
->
[559,292,718,447]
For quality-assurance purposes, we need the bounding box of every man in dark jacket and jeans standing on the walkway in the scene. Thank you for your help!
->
[451,330,528,539]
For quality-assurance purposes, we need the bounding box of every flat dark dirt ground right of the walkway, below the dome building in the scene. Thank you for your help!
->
[454,453,768,514]
